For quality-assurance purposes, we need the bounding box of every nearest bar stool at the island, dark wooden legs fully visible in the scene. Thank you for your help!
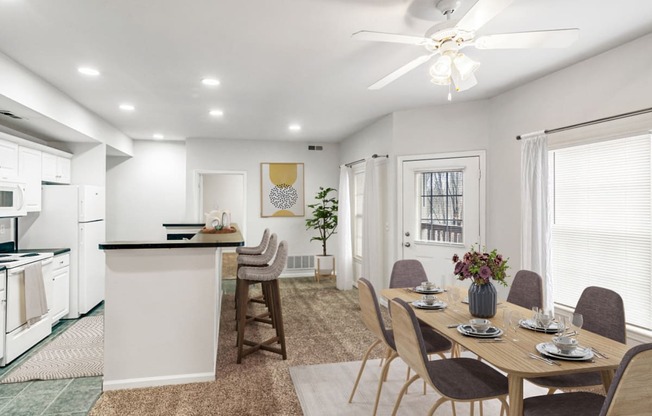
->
[236,241,288,364]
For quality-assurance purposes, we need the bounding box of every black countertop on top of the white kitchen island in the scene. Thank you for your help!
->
[99,224,244,250]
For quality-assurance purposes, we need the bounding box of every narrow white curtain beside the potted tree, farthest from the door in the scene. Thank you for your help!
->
[336,166,353,290]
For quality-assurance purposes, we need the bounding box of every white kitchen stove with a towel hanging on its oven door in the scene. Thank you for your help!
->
[0,253,52,367]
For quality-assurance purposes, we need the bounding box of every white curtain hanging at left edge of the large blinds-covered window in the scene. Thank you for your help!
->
[521,132,553,309]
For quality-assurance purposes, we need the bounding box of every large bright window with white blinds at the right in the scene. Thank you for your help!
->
[550,134,652,329]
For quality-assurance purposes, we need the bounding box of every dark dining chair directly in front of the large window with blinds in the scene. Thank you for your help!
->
[528,286,627,394]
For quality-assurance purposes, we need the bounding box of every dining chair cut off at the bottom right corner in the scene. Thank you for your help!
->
[523,343,652,416]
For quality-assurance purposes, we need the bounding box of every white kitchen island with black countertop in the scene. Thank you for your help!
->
[99,224,244,391]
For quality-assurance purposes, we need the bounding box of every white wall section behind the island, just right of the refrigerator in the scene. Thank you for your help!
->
[106,141,186,241]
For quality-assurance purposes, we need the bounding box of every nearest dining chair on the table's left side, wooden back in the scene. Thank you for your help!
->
[390,298,509,415]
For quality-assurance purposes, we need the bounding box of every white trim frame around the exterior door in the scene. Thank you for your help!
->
[394,150,487,259]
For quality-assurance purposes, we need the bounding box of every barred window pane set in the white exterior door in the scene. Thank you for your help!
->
[419,170,464,243]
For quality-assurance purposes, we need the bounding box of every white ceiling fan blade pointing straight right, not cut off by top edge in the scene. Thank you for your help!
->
[475,29,580,49]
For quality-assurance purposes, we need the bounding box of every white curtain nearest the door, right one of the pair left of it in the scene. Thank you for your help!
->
[362,158,385,290]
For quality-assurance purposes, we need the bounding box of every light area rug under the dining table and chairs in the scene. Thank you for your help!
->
[290,353,547,416]
